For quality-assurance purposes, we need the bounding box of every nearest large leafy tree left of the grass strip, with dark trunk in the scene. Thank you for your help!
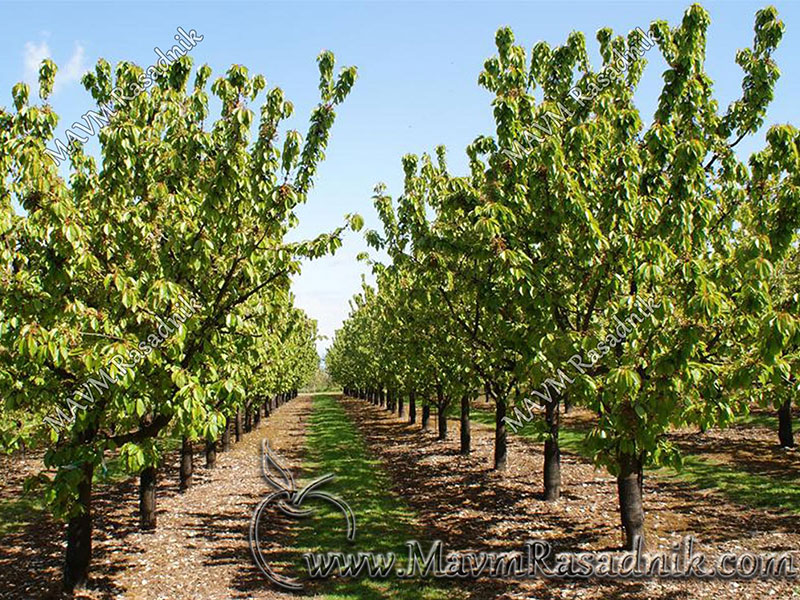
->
[0,52,358,590]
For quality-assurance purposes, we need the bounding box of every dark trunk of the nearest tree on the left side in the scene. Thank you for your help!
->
[64,463,94,593]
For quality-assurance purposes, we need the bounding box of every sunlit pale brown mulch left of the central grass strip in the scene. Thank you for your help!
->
[0,396,318,600]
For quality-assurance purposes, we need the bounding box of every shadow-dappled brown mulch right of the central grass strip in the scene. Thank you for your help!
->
[342,399,800,600]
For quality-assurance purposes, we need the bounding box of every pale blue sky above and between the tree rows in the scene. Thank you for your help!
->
[0,2,800,349]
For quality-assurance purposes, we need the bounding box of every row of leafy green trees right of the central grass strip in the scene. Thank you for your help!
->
[328,5,800,544]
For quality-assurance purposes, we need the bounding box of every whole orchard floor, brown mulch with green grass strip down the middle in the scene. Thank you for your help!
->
[0,396,800,600]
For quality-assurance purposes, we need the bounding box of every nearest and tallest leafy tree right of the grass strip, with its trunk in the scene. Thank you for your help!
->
[473,5,800,547]
